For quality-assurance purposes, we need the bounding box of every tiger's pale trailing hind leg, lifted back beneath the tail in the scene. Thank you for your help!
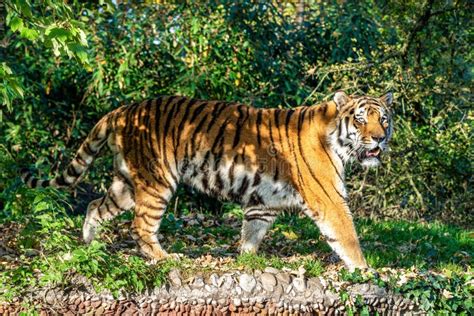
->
[82,176,135,243]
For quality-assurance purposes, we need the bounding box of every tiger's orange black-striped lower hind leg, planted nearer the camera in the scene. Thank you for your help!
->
[131,181,177,261]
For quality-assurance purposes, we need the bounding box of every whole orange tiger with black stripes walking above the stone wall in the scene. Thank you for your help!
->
[22,91,393,270]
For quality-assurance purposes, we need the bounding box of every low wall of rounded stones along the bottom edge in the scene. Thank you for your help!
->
[0,268,422,315]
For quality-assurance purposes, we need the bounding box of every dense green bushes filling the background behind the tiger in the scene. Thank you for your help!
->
[0,1,474,225]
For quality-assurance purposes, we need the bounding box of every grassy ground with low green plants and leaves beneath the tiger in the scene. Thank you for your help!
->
[0,187,474,313]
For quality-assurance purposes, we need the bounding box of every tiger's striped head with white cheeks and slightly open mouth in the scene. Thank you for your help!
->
[333,91,393,167]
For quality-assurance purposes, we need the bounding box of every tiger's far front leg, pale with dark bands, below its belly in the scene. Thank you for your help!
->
[240,206,277,253]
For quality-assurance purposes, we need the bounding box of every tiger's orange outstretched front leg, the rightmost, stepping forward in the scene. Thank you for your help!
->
[306,206,368,271]
